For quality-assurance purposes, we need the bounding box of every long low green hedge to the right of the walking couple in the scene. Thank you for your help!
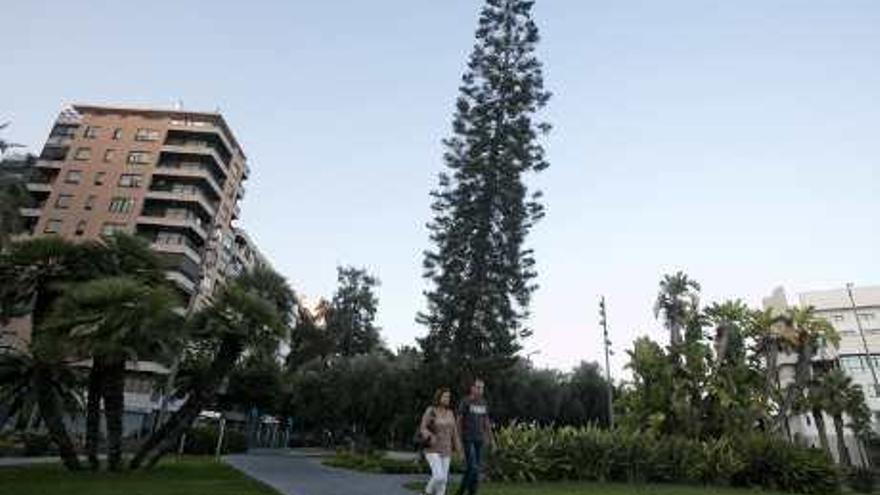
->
[488,425,839,494]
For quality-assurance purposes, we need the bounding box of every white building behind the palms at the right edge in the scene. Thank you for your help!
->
[764,286,880,463]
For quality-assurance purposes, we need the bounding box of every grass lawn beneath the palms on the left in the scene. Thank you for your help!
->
[0,458,278,495]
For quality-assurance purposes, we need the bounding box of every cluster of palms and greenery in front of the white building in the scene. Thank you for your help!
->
[620,272,871,465]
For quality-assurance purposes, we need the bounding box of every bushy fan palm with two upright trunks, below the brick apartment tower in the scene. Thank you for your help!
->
[50,276,182,470]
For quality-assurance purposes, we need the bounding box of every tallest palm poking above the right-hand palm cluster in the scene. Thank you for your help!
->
[654,272,700,349]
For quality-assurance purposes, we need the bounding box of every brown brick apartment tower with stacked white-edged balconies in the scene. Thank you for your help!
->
[21,105,249,304]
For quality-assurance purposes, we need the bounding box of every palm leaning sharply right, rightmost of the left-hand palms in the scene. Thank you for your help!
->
[131,267,296,469]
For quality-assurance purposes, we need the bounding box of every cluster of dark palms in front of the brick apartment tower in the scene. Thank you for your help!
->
[0,235,295,470]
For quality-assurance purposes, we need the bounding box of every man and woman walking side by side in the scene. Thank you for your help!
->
[419,378,494,495]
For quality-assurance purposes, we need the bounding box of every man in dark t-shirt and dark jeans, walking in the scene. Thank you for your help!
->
[458,378,494,495]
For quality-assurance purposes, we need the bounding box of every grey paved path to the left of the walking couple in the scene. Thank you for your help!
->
[224,451,425,495]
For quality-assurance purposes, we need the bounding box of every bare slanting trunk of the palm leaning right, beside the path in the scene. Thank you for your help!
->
[130,337,244,469]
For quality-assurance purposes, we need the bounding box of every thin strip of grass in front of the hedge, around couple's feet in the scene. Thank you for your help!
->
[407,482,782,495]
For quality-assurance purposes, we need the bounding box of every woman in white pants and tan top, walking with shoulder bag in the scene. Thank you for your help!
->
[419,388,461,495]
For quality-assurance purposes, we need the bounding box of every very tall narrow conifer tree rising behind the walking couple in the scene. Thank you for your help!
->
[417,0,550,386]
